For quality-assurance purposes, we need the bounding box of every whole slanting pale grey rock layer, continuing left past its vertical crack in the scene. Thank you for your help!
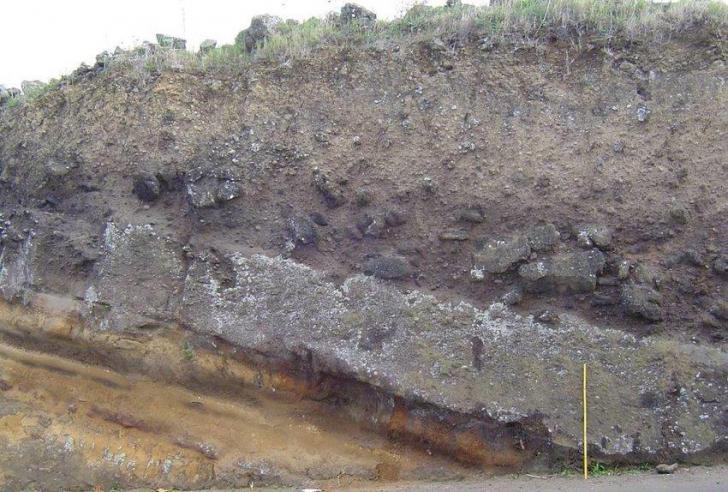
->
[0,223,728,458]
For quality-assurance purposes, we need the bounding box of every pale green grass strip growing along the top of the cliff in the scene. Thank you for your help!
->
[1,0,728,106]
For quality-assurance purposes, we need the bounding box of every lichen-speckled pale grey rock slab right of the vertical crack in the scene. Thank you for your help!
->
[182,246,728,454]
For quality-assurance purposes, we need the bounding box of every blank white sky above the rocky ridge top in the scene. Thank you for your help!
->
[0,0,488,87]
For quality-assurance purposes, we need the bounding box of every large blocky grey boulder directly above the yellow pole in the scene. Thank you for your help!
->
[518,249,605,292]
